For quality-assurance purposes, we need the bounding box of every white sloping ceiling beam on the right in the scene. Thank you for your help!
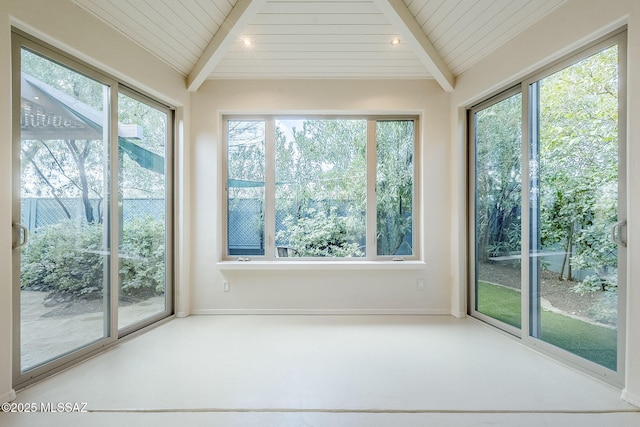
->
[374,0,456,92]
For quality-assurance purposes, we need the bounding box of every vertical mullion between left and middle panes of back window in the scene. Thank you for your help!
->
[264,117,276,260]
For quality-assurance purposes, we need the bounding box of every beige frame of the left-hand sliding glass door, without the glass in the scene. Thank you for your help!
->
[11,28,176,390]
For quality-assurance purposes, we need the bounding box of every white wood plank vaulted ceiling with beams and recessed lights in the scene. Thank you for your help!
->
[71,0,564,90]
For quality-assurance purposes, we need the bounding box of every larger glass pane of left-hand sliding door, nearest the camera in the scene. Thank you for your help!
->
[19,49,110,373]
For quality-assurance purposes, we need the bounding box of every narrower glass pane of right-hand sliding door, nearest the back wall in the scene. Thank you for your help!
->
[472,93,522,328]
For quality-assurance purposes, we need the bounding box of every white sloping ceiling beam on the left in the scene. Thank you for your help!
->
[187,0,267,92]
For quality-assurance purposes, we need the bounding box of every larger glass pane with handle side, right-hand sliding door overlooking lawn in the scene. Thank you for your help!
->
[530,46,624,371]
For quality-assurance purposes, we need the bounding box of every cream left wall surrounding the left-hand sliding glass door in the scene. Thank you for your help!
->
[0,0,189,402]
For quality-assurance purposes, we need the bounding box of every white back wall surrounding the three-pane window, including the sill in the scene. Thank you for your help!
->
[191,80,450,313]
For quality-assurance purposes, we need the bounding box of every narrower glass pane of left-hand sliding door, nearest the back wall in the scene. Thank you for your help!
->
[118,93,170,329]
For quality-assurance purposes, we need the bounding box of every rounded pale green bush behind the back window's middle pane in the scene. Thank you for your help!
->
[276,208,364,257]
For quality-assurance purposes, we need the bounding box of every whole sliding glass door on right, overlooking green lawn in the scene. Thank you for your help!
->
[469,33,626,381]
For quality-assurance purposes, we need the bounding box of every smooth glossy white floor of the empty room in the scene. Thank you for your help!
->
[0,316,640,427]
